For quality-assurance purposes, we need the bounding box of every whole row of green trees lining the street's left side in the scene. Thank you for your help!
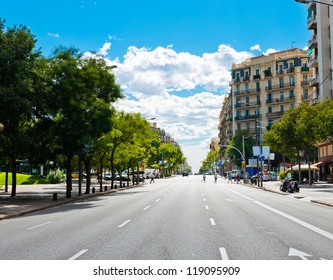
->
[0,19,185,197]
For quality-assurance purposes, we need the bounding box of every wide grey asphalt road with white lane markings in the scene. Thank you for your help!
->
[0,176,333,260]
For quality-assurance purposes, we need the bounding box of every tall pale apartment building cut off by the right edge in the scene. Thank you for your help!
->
[307,1,333,181]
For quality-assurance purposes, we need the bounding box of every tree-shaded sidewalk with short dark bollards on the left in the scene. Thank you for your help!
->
[0,180,144,220]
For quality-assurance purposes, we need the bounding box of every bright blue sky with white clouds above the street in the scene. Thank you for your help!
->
[0,0,310,171]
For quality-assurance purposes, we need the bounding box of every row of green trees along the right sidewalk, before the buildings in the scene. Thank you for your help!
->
[202,99,333,184]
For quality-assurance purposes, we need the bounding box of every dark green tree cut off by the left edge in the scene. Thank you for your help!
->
[0,19,40,196]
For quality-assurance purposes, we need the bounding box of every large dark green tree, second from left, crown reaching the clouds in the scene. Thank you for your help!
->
[51,49,122,197]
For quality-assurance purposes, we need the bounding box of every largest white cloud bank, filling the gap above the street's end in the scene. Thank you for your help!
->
[94,44,253,171]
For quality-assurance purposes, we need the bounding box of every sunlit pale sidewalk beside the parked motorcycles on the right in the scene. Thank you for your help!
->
[246,181,333,207]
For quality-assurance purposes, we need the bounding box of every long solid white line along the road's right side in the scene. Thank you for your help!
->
[230,190,333,240]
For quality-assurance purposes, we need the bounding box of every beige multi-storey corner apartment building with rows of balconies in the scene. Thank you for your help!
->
[219,48,312,168]
